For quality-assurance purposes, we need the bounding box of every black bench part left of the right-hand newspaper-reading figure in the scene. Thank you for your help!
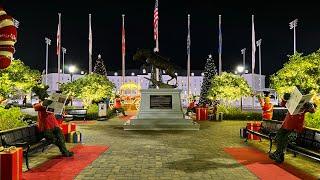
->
[245,120,282,153]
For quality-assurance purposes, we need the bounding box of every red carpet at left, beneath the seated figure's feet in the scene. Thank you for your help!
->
[23,145,109,180]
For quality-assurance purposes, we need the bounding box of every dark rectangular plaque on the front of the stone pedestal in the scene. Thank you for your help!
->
[150,95,172,109]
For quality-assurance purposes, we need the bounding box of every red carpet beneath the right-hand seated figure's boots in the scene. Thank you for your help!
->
[224,148,316,180]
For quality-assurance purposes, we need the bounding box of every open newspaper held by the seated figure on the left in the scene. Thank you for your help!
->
[47,93,68,114]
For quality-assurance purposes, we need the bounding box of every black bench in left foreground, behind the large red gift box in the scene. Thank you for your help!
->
[0,124,50,170]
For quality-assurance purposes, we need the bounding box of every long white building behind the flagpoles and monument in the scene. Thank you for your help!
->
[43,70,265,107]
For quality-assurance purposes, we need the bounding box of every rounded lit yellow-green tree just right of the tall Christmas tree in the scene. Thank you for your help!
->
[208,73,252,102]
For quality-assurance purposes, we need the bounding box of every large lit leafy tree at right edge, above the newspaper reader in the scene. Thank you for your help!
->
[271,50,320,94]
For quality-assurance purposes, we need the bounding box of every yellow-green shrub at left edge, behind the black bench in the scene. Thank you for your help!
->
[0,107,27,131]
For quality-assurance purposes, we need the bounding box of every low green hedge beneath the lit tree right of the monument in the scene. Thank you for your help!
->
[217,105,262,120]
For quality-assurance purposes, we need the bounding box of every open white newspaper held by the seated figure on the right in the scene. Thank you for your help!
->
[286,87,313,115]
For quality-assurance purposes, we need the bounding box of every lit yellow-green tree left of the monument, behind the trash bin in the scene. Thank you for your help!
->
[61,73,115,107]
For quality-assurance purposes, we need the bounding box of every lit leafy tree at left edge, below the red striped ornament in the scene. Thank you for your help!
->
[0,60,41,102]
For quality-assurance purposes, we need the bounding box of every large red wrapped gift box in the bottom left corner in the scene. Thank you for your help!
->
[0,147,23,180]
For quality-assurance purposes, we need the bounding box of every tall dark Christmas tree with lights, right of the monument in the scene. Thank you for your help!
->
[199,54,217,105]
